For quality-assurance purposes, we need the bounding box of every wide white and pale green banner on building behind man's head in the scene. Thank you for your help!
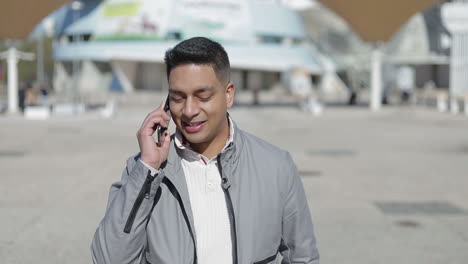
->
[95,0,253,42]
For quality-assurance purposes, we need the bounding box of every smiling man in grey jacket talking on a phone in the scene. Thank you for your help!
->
[91,37,319,264]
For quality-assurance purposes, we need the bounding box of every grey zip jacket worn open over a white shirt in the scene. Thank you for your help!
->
[91,120,319,264]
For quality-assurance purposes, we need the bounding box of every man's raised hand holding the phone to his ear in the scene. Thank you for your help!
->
[137,102,171,169]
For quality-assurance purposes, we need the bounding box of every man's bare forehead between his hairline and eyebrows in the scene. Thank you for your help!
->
[169,64,221,91]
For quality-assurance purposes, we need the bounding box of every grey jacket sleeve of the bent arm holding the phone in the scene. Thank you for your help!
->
[91,155,163,264]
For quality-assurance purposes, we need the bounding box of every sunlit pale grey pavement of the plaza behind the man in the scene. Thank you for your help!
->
[0,95,468,264]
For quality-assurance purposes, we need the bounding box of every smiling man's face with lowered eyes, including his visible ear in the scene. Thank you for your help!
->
[169,64,235,146]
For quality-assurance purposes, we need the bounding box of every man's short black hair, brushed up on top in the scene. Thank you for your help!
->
[164,37,230,83]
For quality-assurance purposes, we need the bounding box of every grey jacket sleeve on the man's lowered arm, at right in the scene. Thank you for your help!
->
[279,153,319,264]
